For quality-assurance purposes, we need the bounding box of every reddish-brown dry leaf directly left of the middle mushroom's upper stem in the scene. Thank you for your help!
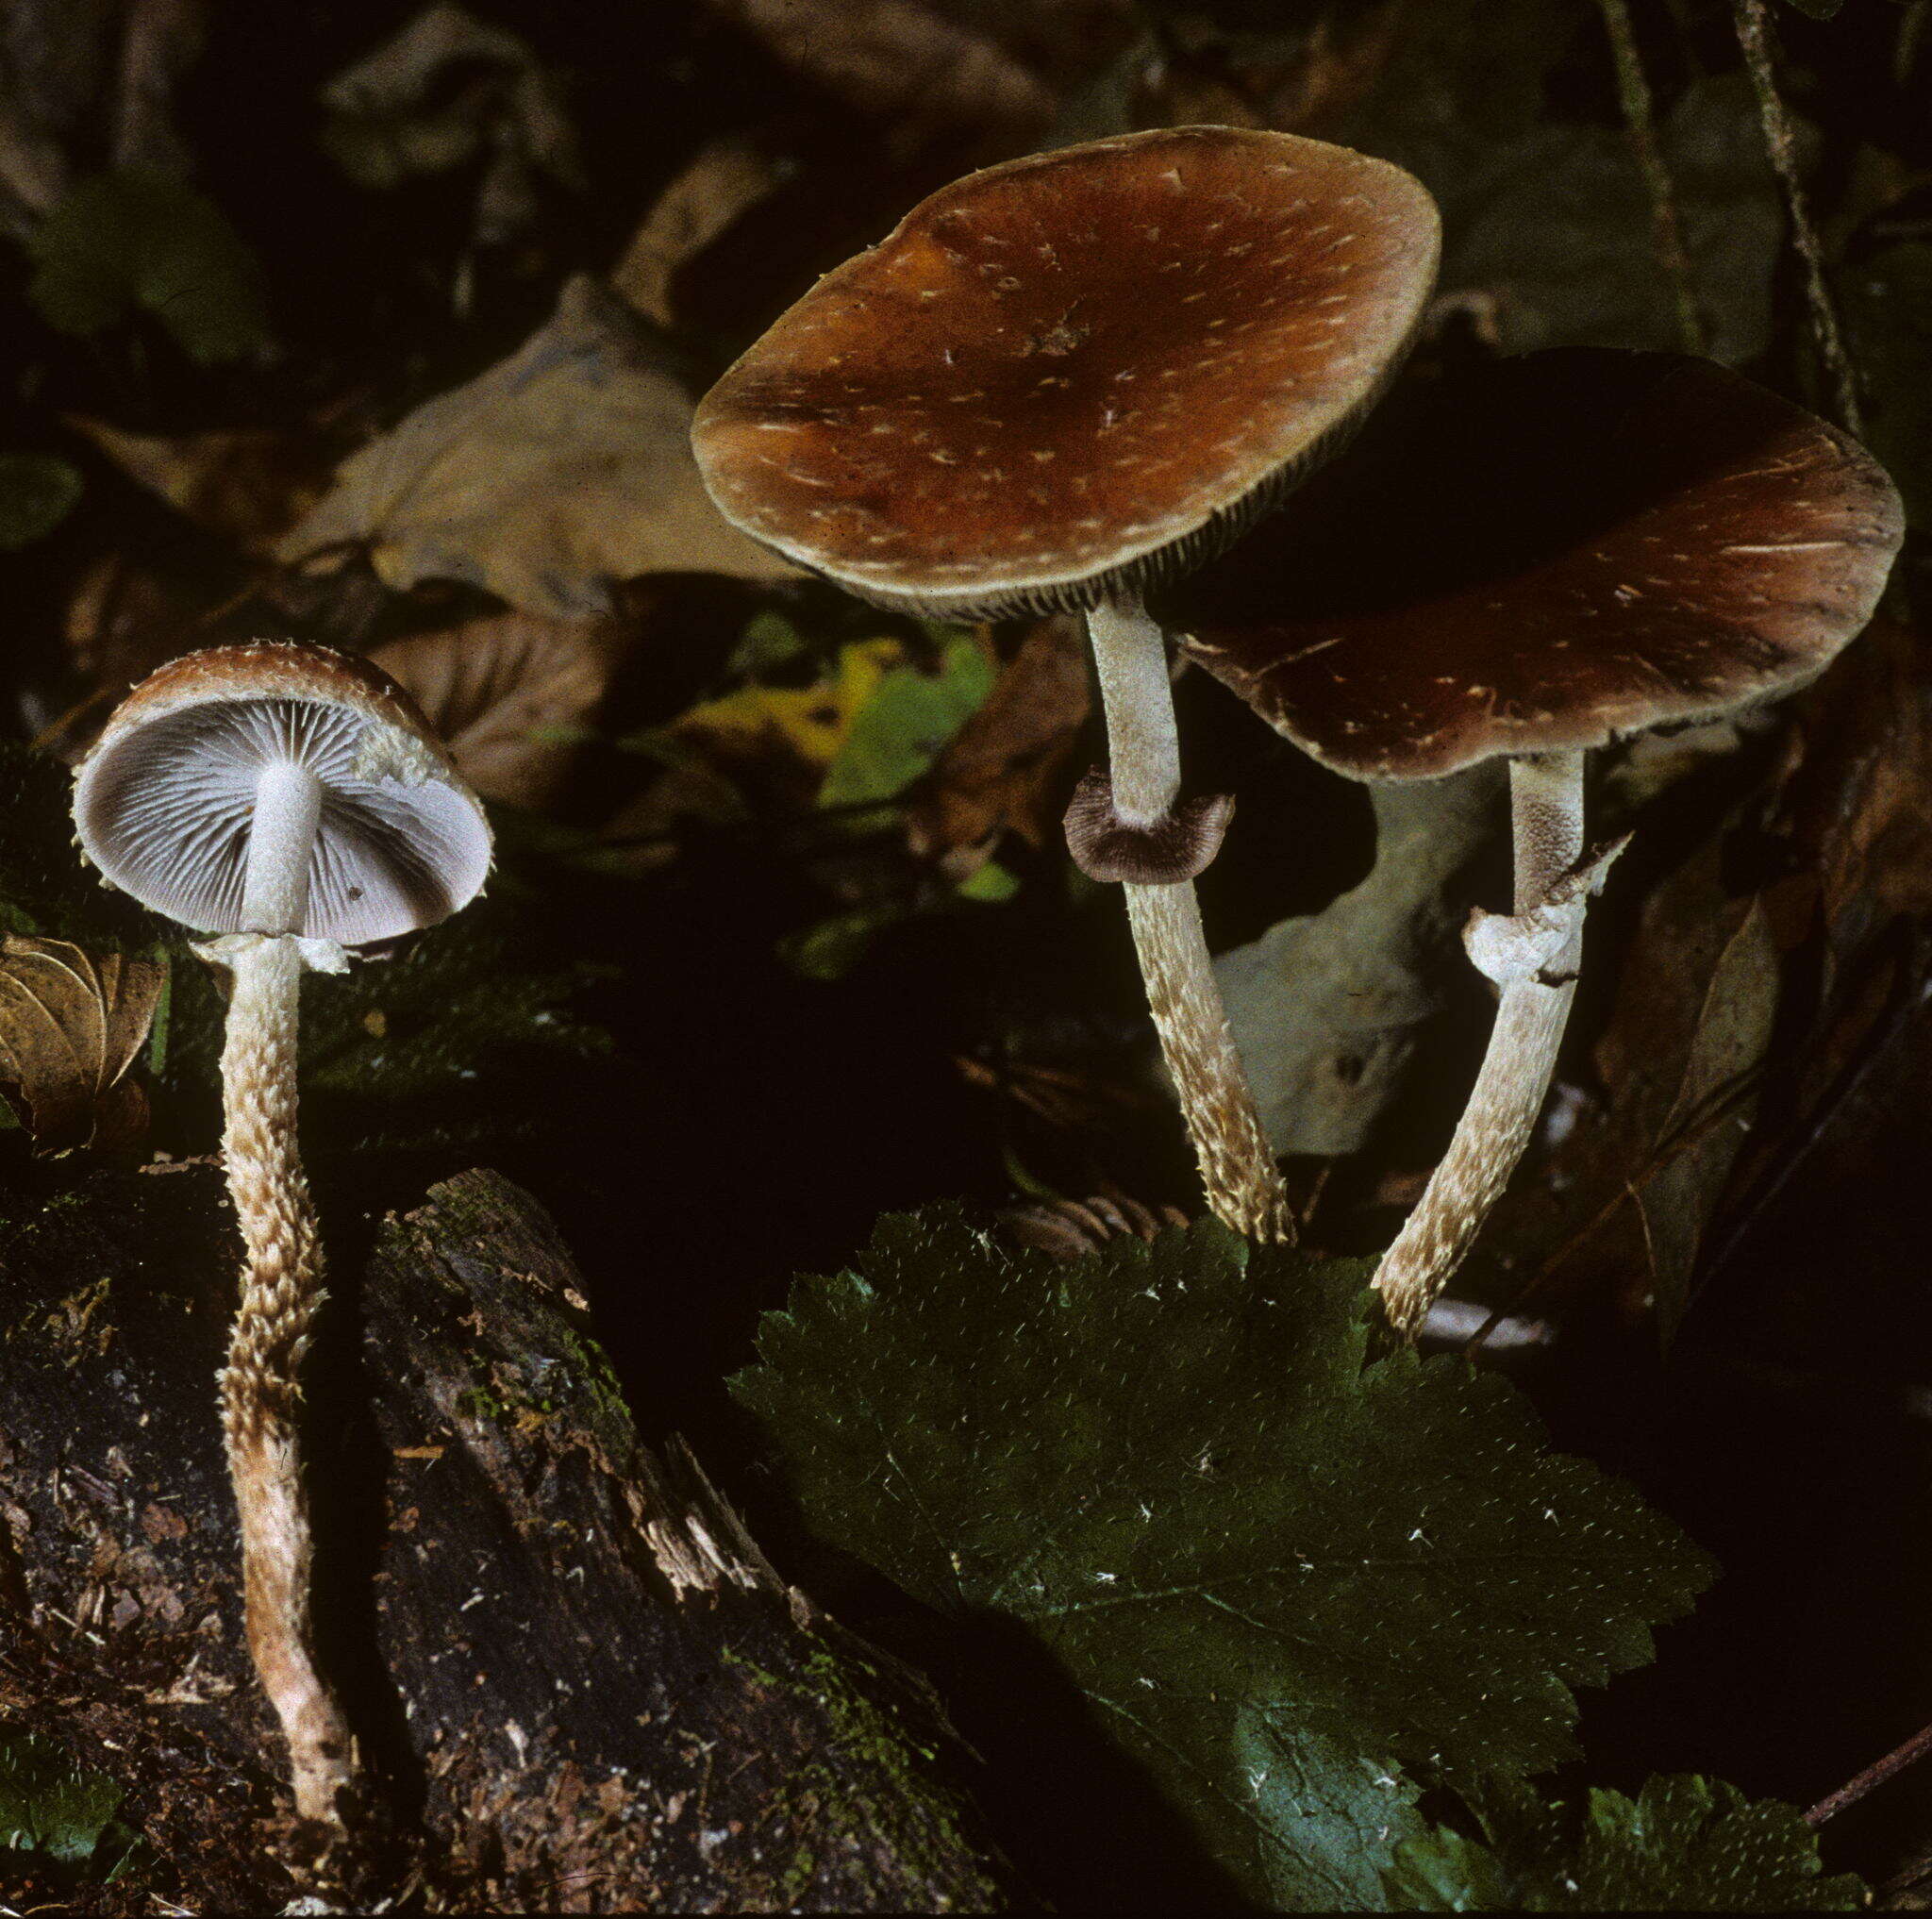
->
[907,614,1091,879]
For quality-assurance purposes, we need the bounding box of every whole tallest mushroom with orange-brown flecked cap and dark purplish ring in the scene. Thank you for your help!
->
[691,127,1438,1237]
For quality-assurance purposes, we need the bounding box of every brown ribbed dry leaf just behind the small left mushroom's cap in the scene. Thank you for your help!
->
[369,612,636,808]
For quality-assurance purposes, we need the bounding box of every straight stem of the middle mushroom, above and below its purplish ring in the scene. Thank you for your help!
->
[1088,593,1294,1241]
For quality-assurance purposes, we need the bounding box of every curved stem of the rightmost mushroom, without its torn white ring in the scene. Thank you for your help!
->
[1375,752,1586,1342]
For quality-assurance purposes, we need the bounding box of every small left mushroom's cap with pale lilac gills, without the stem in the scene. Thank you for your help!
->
[74,642,491,945]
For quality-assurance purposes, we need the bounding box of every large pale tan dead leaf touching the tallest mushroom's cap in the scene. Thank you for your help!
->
[276,275,798,618]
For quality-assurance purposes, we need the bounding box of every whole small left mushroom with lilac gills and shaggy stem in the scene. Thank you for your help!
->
[74,645,491,1828]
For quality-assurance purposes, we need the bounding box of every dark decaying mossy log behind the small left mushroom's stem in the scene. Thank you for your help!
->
[0,1167,1014,1913]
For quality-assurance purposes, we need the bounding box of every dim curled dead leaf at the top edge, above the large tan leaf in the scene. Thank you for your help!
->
[323,0,586,245]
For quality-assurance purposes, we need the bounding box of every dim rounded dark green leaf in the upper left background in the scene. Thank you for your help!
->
[27,172,271,365]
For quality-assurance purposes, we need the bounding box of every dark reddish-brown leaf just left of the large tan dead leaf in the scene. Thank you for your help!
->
[66,413,328,555]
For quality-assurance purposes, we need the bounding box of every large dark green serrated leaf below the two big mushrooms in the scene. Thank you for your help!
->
[734,1211,1709,1890]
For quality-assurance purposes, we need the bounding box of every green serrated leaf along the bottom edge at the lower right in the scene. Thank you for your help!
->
[1383,1774,1866,1913]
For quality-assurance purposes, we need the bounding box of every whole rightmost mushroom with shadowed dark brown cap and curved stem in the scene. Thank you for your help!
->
[1171,348,1903,1337]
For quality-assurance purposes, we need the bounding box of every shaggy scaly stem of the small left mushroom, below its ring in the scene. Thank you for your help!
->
[220,931,358,1830]
